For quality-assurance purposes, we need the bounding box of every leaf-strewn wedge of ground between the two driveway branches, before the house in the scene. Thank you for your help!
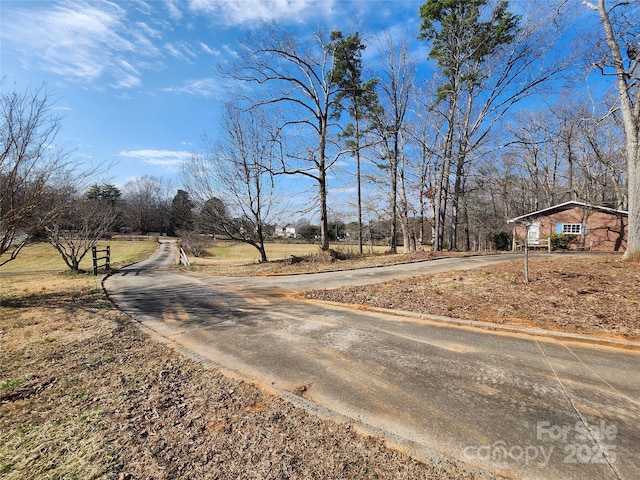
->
[307,254,640,340]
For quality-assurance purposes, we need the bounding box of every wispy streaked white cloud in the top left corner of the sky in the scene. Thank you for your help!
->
[2,1,168,88]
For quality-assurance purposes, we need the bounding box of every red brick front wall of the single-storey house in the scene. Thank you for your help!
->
[515,208,627,252]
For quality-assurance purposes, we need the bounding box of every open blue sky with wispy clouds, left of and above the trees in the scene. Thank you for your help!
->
[0,0,422,186]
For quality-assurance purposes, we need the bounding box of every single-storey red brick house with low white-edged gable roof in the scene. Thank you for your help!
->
[508,201,628,252]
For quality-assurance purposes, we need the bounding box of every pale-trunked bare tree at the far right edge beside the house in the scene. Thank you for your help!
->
[584,0,640,258]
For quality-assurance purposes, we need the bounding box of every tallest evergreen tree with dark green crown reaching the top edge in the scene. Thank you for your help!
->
[419,0,520,250]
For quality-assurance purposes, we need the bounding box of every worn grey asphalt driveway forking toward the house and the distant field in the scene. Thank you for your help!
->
[104,240,640,479]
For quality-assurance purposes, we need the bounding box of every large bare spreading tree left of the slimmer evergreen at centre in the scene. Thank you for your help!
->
[226,24,356,251]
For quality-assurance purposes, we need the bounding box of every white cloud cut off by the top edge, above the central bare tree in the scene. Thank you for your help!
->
[189,0,335,25]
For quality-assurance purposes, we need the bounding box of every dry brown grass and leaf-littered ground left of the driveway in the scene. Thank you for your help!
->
[0,276,490,480]
